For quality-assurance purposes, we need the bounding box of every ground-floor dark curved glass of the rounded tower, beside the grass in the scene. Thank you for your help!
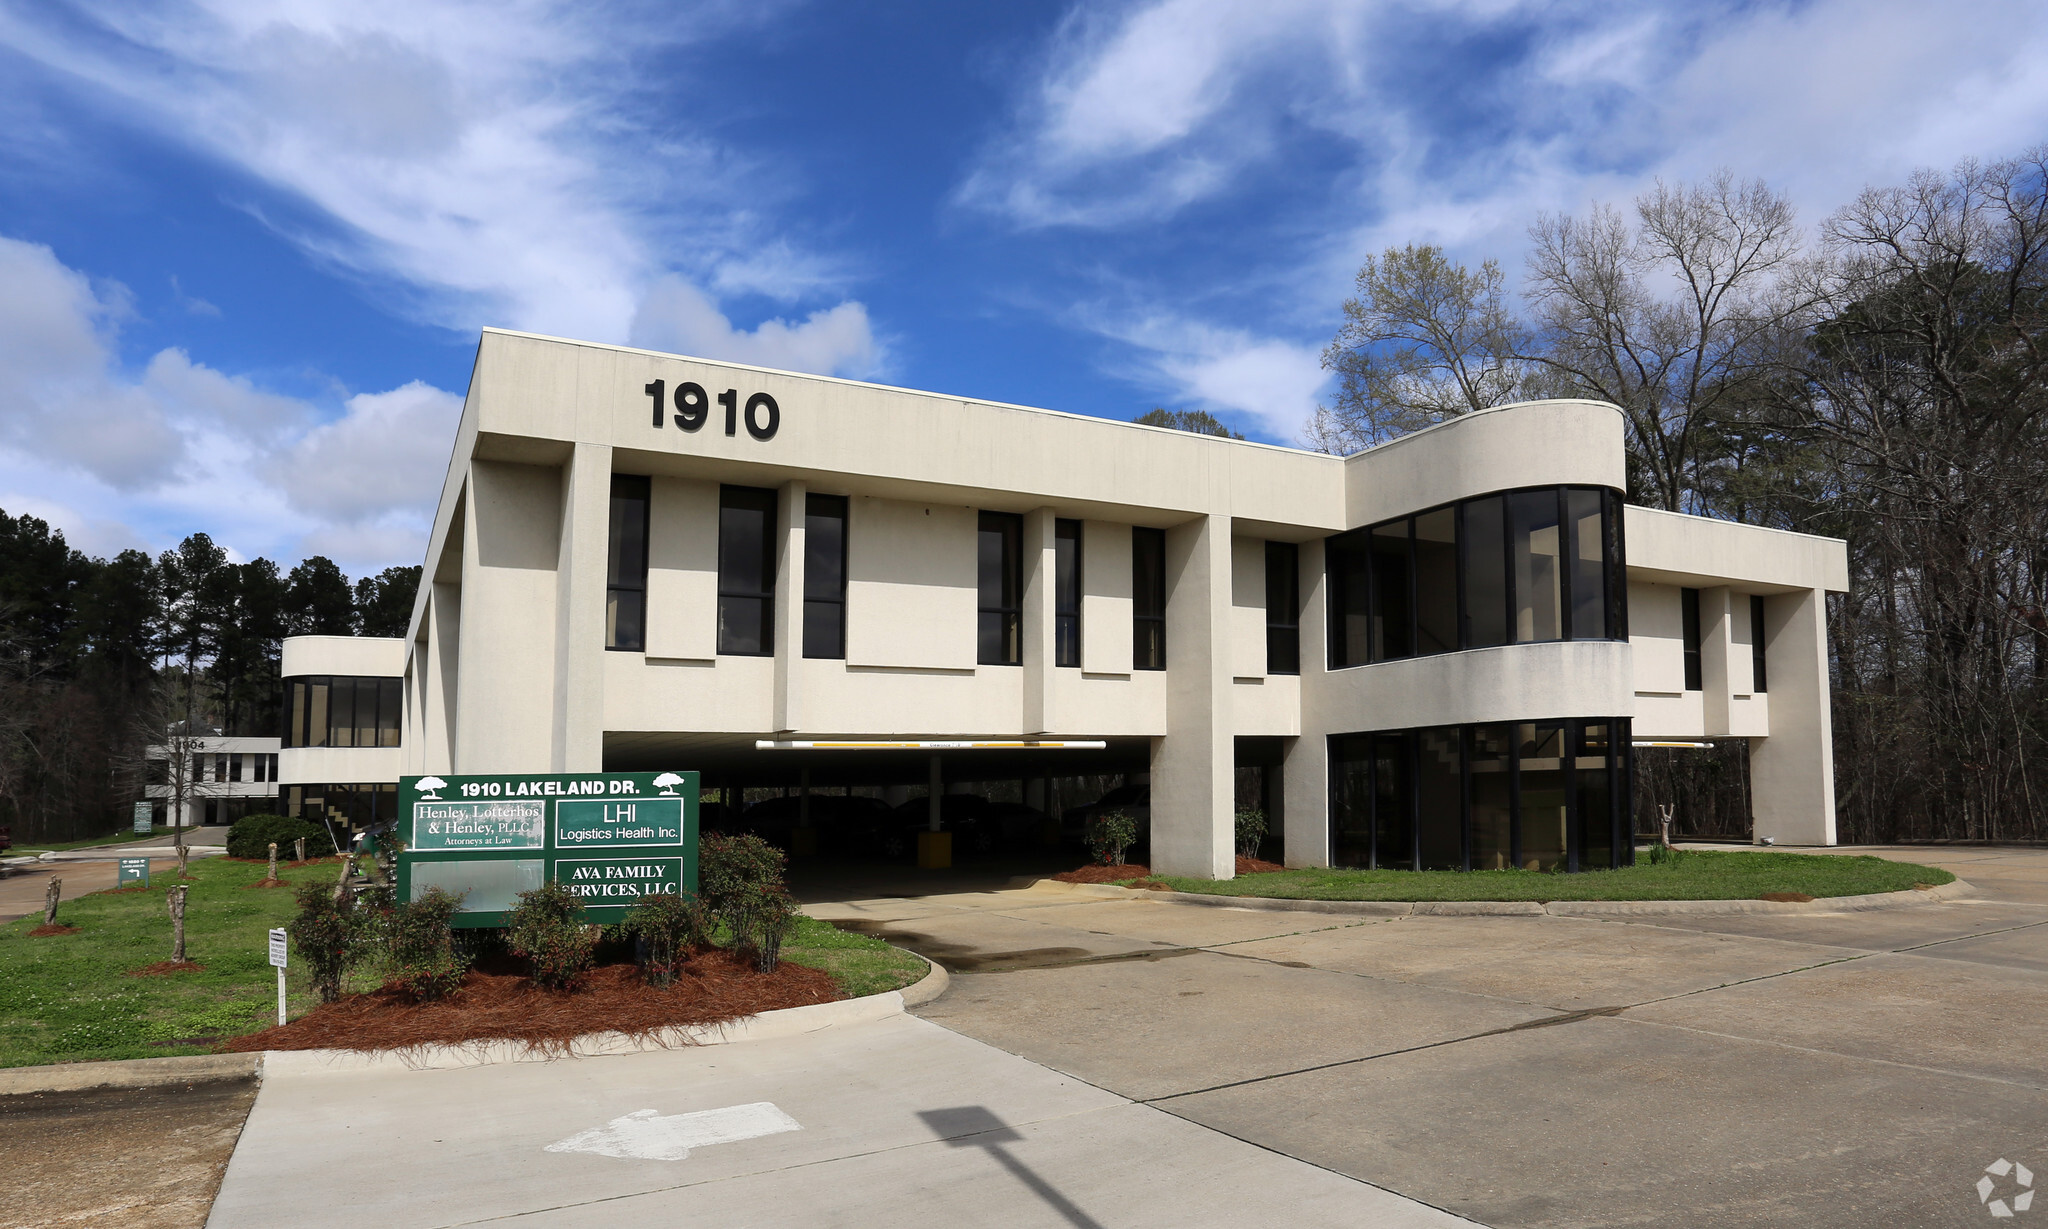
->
[1329,717,1634,871]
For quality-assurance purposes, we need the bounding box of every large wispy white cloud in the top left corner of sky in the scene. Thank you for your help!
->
[0,0,864,374]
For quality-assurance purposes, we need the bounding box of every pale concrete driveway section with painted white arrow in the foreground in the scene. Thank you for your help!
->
[209,1016,1466,1229]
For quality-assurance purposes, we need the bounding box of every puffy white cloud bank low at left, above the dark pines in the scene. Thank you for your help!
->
[0,238,461,571]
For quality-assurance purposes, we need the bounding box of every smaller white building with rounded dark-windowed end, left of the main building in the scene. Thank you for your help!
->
[270,635,406,828]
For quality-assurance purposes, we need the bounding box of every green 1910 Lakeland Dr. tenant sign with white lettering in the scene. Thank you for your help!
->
[397,772,698,926]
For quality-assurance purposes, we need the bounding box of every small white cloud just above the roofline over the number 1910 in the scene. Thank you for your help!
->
[631,277,881,375]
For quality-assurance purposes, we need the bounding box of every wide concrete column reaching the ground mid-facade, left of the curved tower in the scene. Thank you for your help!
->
[1151,516,1237,879]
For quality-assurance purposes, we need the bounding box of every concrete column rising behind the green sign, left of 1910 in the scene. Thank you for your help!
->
[551,442,612,772]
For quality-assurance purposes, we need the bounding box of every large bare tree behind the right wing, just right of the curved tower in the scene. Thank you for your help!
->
[1528,172,1806,512]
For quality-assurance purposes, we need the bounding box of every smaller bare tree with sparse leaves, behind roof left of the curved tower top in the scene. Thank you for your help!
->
[1309,244,1532,453]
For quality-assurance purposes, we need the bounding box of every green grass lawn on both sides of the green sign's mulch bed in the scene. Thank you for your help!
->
[0,858,926,1067]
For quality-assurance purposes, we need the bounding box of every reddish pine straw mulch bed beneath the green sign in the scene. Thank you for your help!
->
[223,948,846,1055]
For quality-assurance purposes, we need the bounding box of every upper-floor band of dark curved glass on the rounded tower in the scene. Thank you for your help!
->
[1325,488,1628,670]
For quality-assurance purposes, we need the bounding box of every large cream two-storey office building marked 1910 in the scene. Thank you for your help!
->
[376,330,1847,877]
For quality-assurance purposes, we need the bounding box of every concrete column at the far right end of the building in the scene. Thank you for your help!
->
[1749,590,1835,846]
